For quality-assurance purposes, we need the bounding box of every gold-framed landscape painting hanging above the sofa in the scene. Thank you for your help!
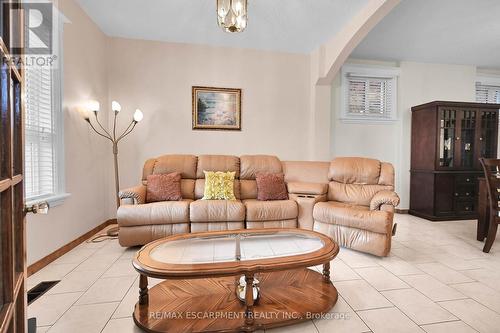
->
[192,87,241,131]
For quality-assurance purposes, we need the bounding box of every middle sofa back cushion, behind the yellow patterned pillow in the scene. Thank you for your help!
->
[194,155,240,200]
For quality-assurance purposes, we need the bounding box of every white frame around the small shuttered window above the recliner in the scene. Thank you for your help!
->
[340,64,400,123]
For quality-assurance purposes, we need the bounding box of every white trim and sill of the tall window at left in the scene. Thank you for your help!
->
[25,8,71,207]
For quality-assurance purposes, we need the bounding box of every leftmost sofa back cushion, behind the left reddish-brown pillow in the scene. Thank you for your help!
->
[142,155,198,199]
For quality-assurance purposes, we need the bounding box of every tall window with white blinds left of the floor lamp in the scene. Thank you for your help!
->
[24,10,68,206]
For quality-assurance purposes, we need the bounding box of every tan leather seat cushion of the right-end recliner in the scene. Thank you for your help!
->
[313,201,393,234]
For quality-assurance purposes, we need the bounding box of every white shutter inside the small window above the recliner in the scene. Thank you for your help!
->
[346,75,394,119]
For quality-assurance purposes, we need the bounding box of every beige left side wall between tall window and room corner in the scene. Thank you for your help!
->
[27,0,112,264]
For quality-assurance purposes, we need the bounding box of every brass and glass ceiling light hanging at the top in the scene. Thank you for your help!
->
[217,0,248,32]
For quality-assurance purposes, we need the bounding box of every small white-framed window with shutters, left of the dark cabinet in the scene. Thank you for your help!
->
[341,66,397,121]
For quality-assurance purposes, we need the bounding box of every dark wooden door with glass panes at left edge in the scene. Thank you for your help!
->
[0,1,26,333]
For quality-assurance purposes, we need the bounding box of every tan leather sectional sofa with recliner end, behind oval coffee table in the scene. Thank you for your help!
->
[117,155,399,256]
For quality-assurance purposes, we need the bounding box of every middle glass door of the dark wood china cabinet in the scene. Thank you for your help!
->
[459,110,477,168]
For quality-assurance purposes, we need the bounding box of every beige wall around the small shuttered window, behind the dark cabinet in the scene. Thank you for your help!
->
[331,60,476,209]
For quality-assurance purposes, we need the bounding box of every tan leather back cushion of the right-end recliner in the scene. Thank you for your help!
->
[328,157,394,206]
